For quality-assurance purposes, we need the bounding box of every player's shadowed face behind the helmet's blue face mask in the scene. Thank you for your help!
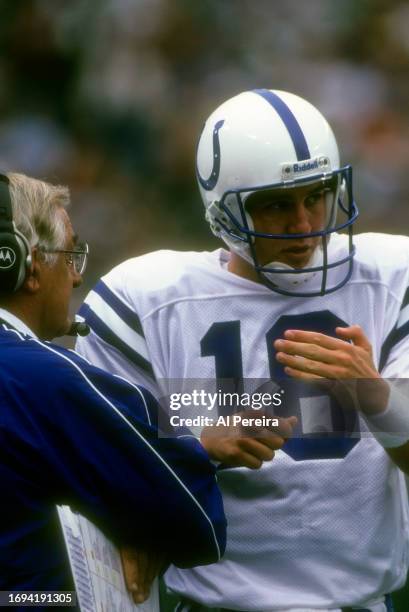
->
[246,183,330,268]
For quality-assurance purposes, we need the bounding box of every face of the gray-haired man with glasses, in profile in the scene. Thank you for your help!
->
[42,209,82,339]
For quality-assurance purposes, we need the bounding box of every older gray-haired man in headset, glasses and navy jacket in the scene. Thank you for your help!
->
[0,174,225,608]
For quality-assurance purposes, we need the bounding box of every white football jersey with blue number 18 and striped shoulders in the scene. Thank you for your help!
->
[77,234,409,612]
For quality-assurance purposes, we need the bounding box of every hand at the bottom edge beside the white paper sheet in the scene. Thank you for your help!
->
[120,546,165,604]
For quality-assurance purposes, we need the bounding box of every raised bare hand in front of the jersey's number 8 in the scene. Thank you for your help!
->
[274,325,389,414]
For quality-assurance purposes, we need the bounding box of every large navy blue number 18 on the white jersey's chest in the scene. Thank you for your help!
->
[200,310,359,461]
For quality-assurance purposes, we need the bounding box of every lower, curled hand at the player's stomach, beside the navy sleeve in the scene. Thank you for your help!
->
[200,410,297,470]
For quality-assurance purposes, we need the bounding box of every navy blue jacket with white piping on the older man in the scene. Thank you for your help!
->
[0,324,226,590]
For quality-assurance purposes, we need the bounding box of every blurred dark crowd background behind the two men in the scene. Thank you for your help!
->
[0,0,409,316]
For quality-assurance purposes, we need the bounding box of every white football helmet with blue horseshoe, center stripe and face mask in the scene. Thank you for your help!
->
[196,89,358,297]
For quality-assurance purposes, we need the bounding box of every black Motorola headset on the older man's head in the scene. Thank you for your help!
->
[0,173,31,293]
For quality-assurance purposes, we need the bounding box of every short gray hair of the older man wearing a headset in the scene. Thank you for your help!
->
[7,172,70,265]
